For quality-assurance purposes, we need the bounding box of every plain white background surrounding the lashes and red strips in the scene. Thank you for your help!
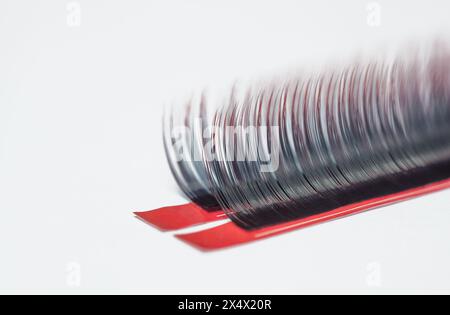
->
[0,0,450,294]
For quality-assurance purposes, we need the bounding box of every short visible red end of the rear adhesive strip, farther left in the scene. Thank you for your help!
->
[134,203,227,231]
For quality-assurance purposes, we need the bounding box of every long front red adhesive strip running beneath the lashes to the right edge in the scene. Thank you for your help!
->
[176,179,450,251]
